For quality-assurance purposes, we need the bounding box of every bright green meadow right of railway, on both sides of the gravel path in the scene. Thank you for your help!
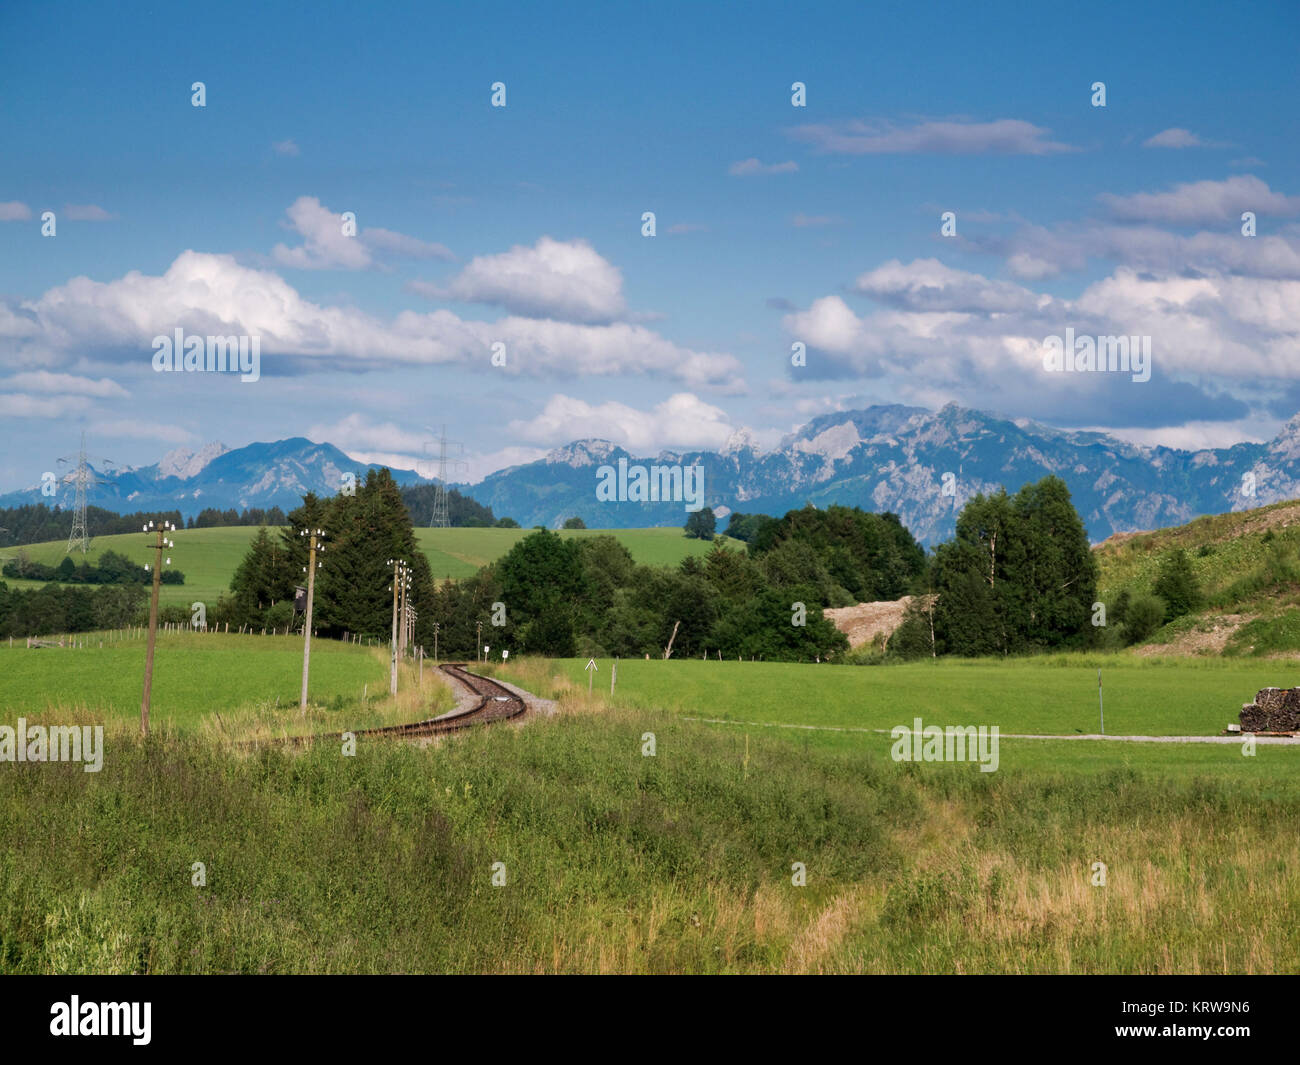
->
[493,655,1300,802]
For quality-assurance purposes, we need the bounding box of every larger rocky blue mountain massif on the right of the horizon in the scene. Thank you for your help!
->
[469,404,1300,544]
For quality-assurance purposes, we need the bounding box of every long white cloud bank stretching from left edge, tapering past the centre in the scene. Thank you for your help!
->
[0,251,742,391]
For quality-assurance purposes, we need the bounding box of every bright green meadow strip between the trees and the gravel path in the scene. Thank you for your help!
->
[507,654,1295,736]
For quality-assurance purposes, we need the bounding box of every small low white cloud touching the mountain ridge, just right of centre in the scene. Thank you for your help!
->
[508,391,736,455]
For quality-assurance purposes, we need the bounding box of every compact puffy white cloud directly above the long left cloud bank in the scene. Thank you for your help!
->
[411,237,627,322]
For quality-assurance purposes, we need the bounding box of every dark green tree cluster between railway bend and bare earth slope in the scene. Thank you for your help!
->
[436,507,924,661]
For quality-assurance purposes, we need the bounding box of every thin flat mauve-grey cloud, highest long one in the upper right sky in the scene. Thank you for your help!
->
[787,118,1074,155]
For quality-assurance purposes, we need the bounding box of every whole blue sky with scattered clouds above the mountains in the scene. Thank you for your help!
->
[0,3,1300,490]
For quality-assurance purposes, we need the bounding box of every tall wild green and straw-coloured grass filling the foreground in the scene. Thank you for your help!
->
[0,702,1300,973]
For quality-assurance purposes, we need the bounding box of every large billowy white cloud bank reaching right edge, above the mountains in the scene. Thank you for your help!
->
[783,260,1300,395]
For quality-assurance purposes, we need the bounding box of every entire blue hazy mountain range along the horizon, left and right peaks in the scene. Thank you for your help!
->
[10,404,1300,544]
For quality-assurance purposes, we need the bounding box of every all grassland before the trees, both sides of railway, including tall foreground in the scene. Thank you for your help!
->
[0,635,1300,973]
